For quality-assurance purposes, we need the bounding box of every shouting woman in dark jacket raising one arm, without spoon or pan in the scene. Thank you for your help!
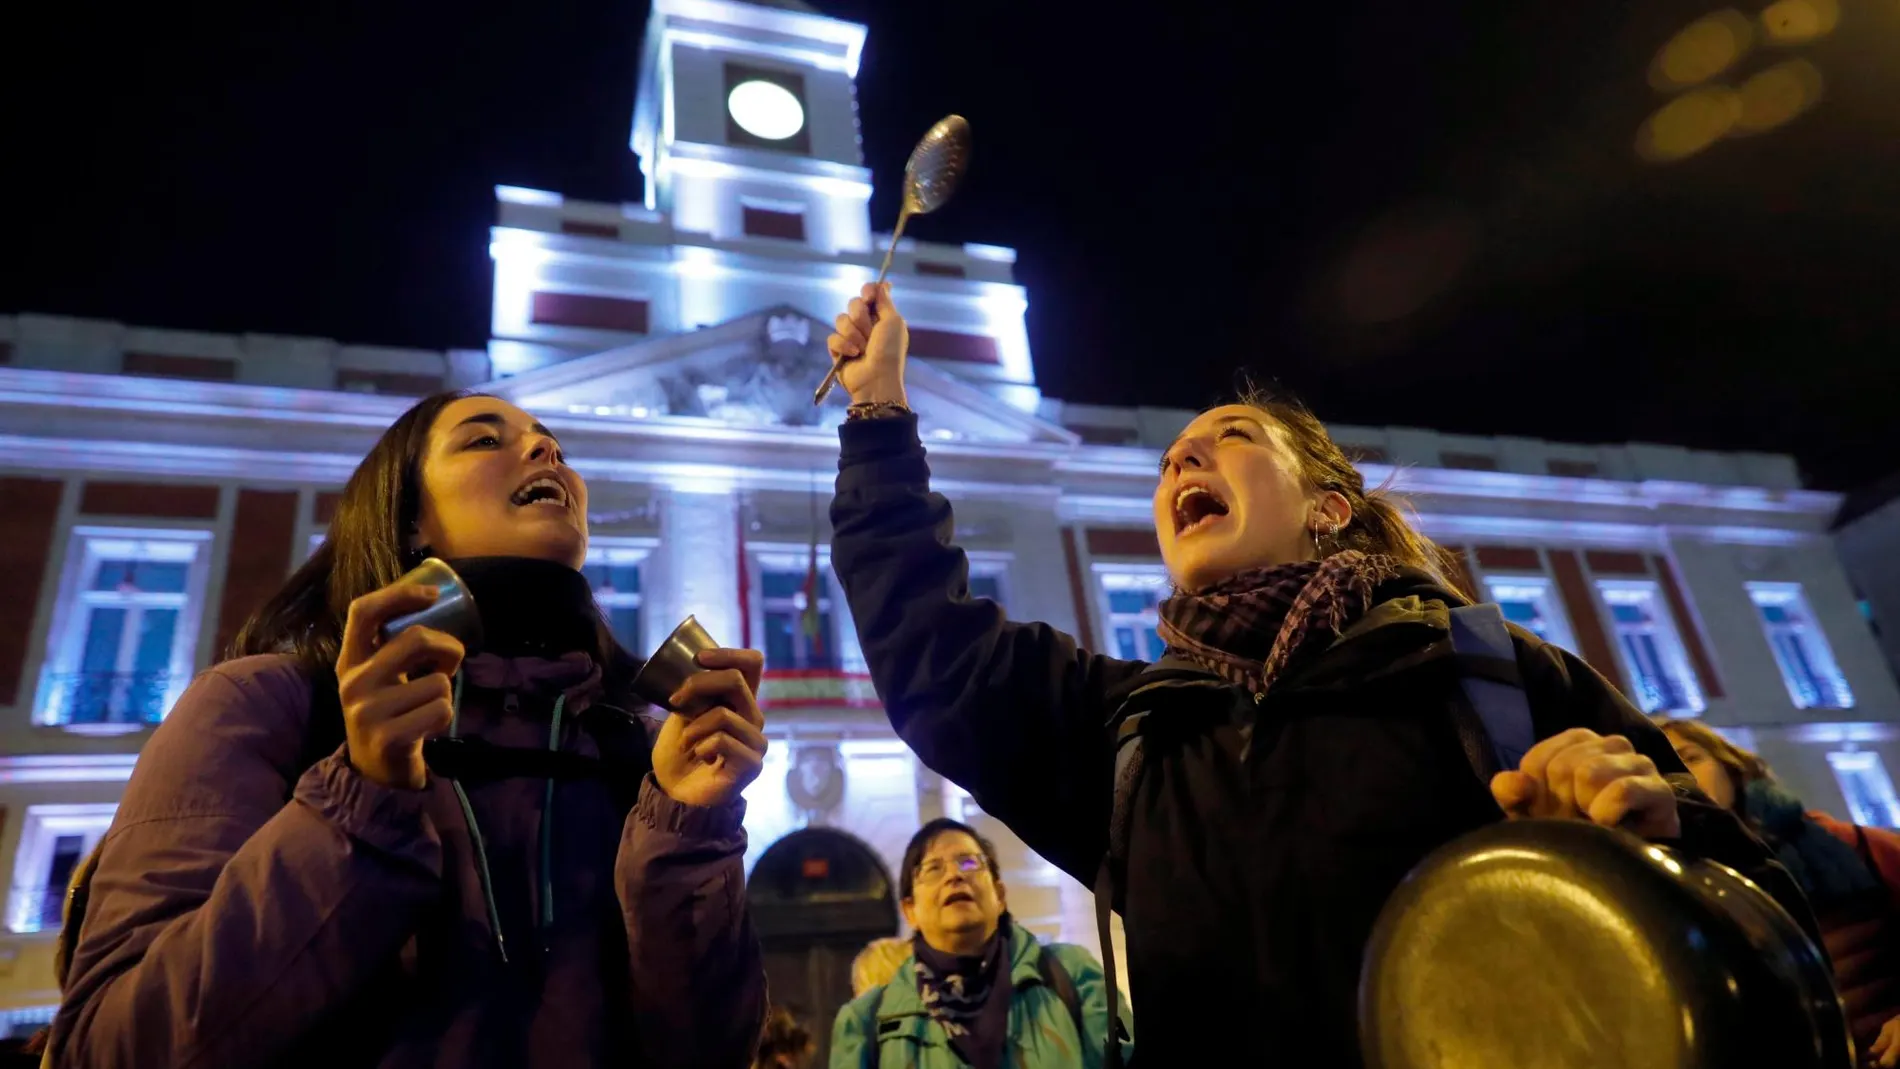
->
[830,287,1805,1065]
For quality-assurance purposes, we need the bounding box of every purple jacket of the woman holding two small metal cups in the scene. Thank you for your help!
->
[42,657,766,1069]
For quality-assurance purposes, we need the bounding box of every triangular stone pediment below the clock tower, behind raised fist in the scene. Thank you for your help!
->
[488,306,1075,442]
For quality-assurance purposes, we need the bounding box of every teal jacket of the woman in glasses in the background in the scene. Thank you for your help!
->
[830,925,1134,1069]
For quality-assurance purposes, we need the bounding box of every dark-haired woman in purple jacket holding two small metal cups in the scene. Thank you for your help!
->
[51,395,766,1069]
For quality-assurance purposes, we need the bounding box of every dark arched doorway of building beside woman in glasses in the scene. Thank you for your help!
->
[747,828,897,1067]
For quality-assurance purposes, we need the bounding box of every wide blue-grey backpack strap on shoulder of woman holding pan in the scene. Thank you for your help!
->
[1450,604,1537,782]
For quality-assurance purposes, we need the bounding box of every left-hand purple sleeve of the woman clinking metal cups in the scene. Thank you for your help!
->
[53,659,443,1069]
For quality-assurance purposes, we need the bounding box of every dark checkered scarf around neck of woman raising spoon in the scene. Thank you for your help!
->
[1161,549,1398,695]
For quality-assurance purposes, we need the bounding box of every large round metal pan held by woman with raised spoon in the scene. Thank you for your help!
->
[1359,820,1854,1069]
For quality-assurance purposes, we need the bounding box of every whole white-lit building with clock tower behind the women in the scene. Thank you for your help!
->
[0,0,1900,1029]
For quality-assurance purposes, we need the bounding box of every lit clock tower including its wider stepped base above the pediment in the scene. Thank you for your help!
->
[488,0,1041,420]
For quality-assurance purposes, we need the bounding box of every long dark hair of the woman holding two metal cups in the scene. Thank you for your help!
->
[228,389,640,699]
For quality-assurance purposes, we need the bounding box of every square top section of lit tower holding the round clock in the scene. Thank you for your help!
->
[633,0,870,254]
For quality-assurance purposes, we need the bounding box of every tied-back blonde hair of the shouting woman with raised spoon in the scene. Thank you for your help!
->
[1239,385,1474,598]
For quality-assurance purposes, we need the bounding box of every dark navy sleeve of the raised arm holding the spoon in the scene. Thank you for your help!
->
[832,414,1144,883]
